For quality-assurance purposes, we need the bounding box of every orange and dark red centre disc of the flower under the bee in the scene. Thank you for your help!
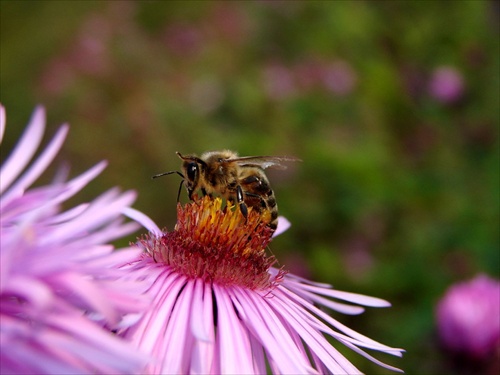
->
[142,196,281,289]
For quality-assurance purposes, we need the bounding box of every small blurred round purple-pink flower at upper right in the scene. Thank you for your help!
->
[429,66,464,104]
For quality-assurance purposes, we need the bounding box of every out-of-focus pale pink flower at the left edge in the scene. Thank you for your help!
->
[0,106,148,374]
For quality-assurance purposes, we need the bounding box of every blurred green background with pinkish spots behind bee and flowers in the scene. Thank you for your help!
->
[0,1,500,374]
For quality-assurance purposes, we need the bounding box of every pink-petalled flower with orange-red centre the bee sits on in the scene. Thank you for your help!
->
[119,197,402,374]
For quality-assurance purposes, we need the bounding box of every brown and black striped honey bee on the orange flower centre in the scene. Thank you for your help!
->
[153,150,300,230]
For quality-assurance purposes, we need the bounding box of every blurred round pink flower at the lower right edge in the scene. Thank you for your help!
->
[436,275,500,359]
